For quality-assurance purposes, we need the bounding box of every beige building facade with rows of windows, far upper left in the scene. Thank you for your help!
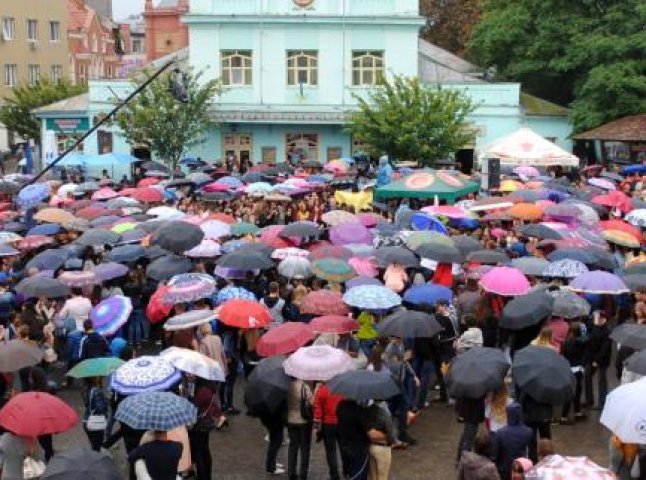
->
[0,0,68,151]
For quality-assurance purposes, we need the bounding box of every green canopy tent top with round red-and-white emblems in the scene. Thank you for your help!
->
[374,168,480,203]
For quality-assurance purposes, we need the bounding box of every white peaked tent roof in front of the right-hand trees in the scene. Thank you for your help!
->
[480,128,579,167]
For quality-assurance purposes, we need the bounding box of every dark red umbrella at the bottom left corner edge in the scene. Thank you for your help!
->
[0,392,79,438]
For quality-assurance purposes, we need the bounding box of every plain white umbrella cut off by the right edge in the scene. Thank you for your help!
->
[600,378,646,444]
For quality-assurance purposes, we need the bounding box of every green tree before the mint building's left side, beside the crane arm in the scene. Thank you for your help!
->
[116,72,221,169]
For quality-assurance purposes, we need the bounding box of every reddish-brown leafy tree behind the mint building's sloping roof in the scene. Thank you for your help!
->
[420,0,481,56]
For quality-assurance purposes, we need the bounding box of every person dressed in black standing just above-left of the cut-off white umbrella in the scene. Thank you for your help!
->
[584,311,612,410]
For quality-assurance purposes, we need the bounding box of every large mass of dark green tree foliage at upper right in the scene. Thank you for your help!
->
[469,0,646,131]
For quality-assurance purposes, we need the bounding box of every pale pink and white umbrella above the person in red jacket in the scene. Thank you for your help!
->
[283,345,354,382]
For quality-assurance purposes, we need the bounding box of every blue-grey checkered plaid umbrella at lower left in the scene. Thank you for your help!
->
[114,391,197,431]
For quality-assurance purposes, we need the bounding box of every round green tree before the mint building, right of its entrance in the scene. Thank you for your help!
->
[347,76,474,165]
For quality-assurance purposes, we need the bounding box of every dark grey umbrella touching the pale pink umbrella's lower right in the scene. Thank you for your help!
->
[327,370,400,402]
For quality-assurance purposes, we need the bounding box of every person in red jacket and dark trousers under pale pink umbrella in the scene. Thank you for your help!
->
[314,383,344,480]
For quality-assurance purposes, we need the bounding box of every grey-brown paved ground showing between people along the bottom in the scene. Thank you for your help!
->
[55,378,608,480]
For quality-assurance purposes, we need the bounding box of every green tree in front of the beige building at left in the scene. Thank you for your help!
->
[0,79,87,143]
